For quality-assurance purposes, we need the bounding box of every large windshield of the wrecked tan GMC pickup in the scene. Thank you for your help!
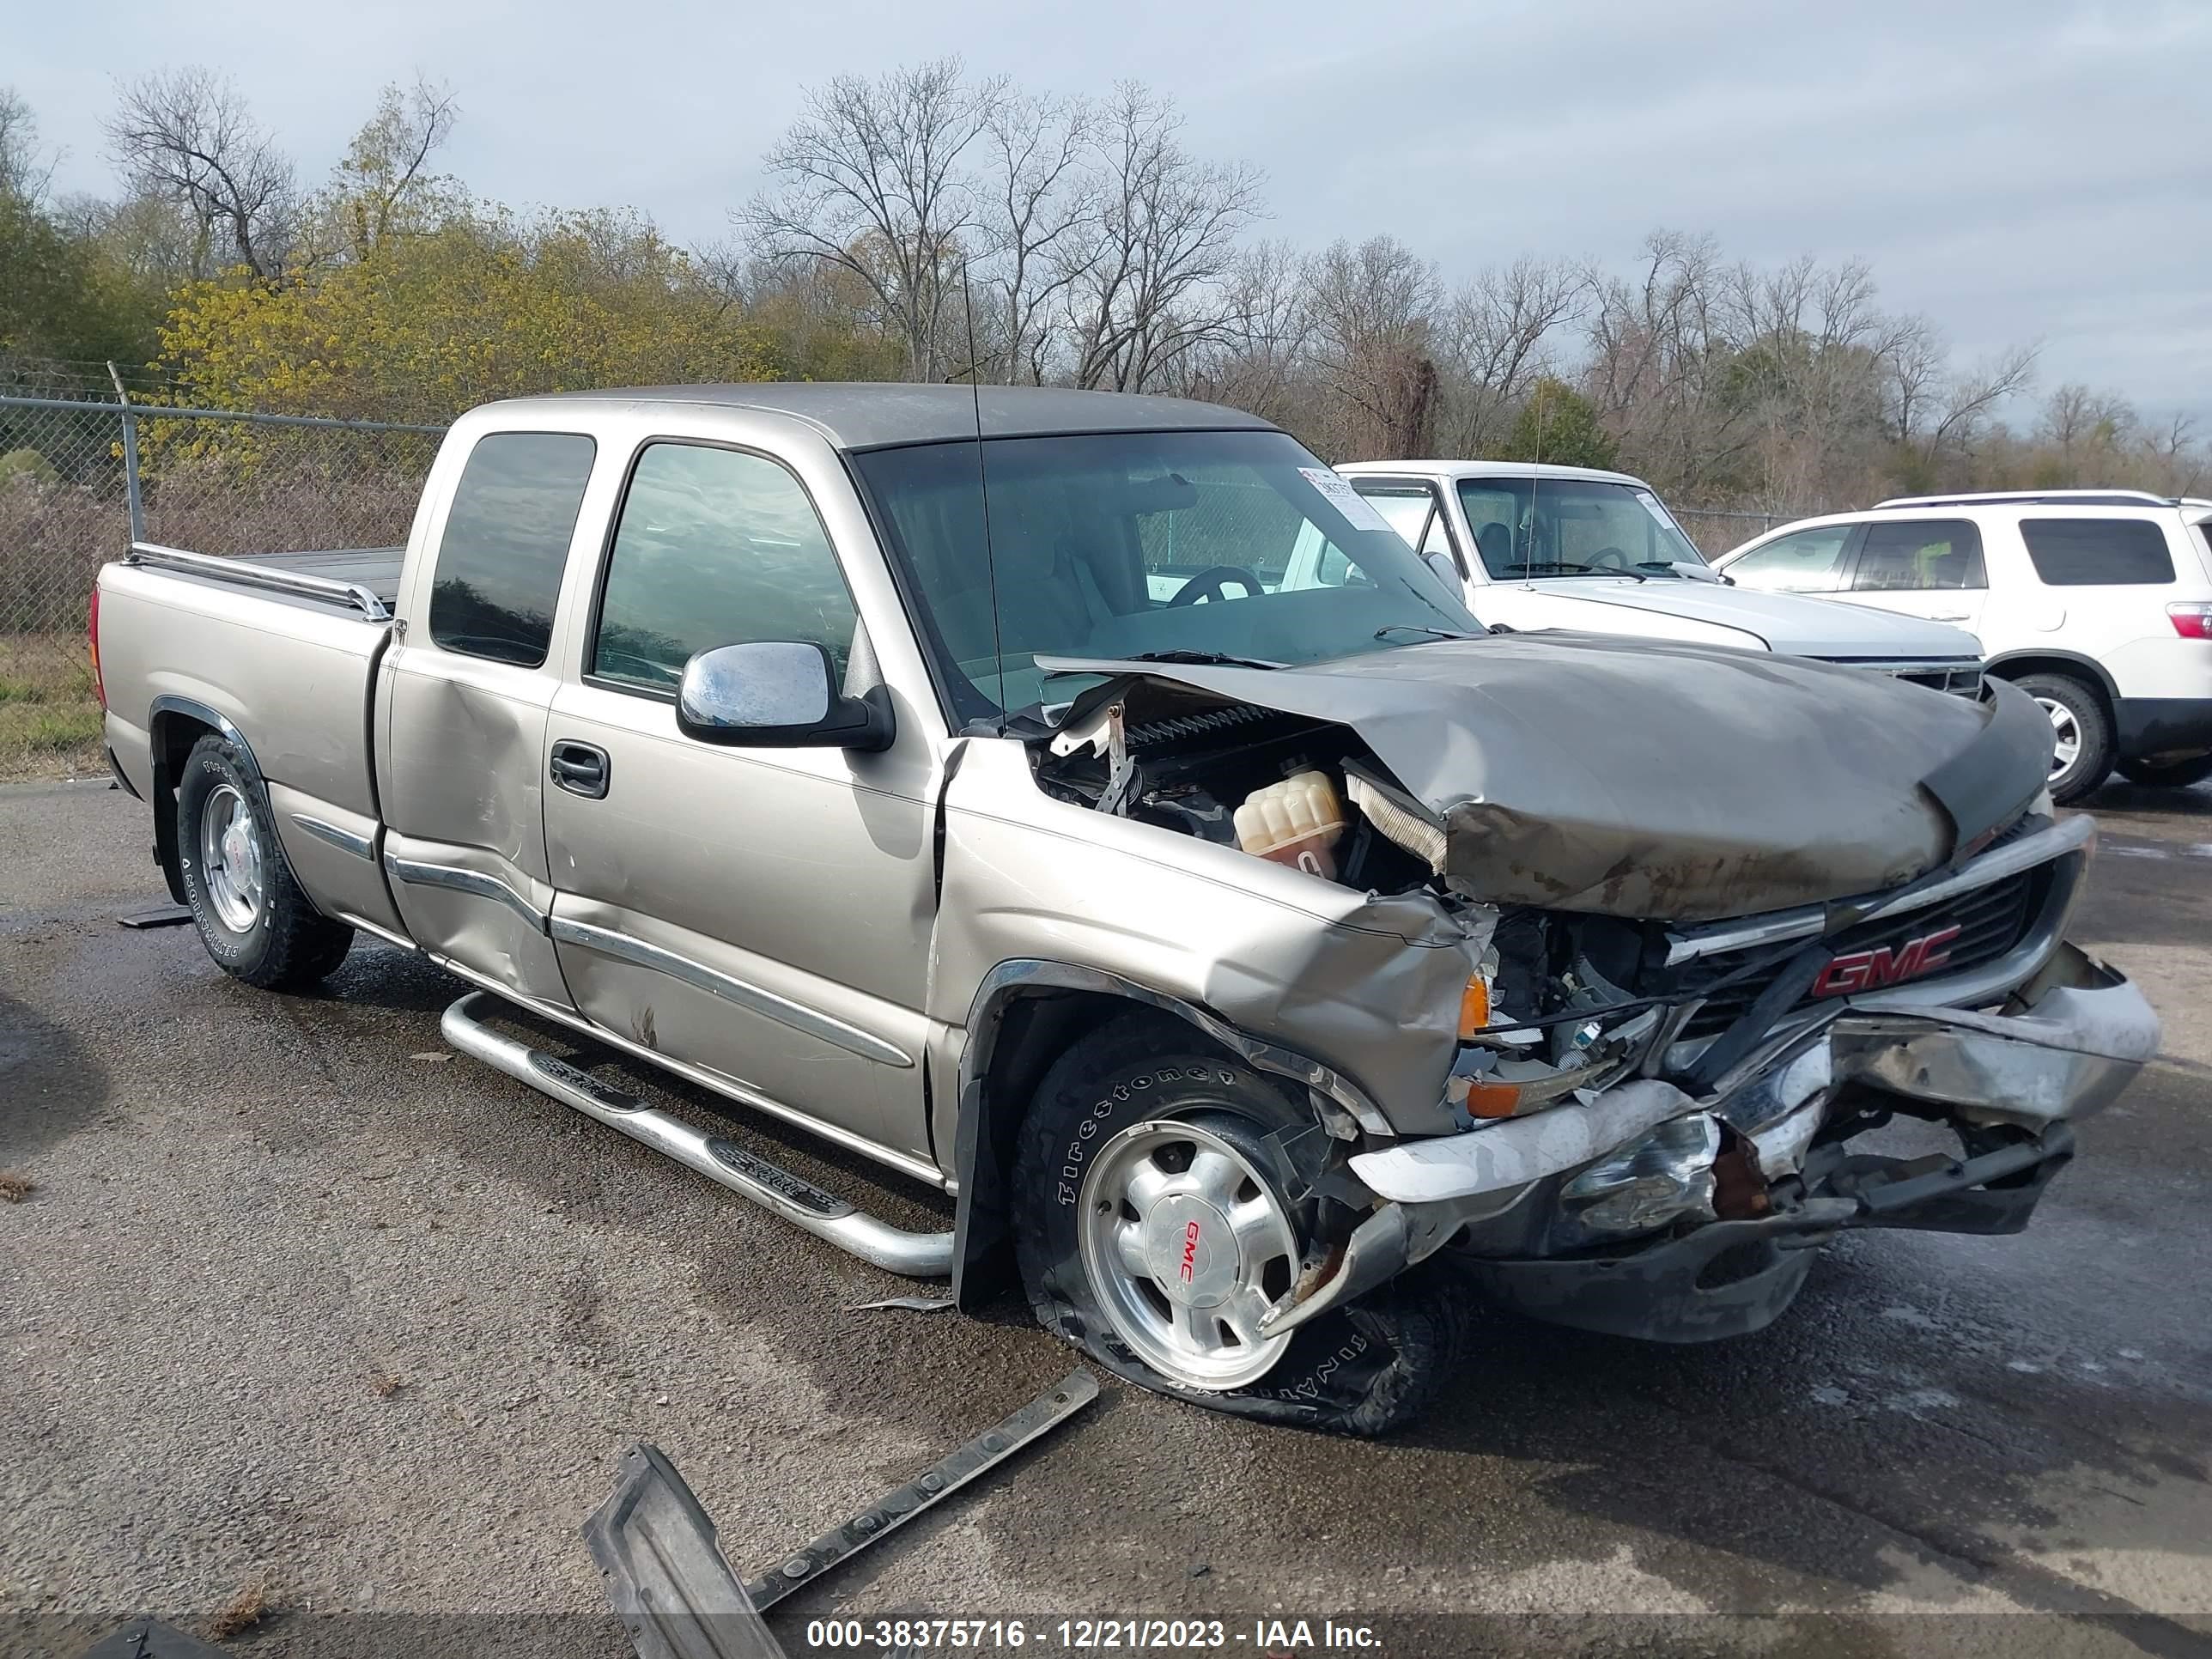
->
[852,431,1482,723]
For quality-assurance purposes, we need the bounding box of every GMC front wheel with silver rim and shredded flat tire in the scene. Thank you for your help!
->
[1013,1015,1464,1436]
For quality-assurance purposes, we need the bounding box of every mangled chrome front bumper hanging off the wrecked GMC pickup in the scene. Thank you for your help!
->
[1274,945,2159,1343]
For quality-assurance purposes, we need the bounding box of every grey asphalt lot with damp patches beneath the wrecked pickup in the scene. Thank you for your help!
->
[0,785,2212,1659]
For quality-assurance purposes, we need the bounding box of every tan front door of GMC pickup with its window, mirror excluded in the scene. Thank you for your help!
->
[540,438,936,1179]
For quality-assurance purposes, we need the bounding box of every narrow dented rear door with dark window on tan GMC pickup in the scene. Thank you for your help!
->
[376,431,598,1006]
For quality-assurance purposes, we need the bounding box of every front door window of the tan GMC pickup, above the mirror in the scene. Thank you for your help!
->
[588,442,858,695]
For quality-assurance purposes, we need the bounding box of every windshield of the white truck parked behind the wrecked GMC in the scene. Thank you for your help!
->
[1460,477,1705,581]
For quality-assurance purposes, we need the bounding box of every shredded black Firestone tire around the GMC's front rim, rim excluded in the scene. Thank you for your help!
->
[1013,1015,1471,1436]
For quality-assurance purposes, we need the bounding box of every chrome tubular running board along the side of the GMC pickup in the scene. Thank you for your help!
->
[438,991,953,1279]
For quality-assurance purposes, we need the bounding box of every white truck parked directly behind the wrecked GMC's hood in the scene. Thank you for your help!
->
[1336,460,1982,696]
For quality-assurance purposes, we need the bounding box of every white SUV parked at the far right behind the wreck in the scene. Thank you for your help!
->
[1714,489,2212,801]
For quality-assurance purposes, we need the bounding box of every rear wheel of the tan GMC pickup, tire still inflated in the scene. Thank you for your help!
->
[177,734,354,991]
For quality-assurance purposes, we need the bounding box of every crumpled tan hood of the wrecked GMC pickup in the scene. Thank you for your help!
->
[1040,633,2051,921]
